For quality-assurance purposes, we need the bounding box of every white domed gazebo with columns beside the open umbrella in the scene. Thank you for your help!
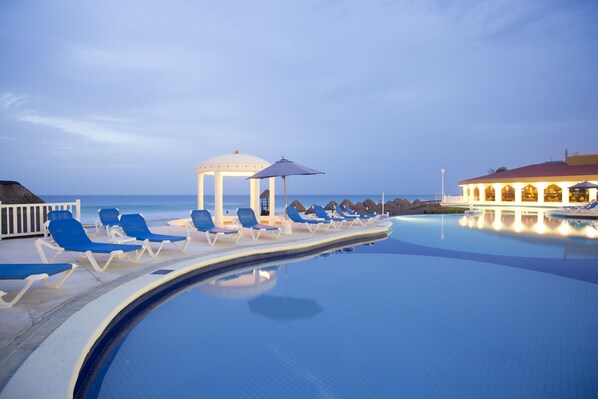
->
[195,151,276,226]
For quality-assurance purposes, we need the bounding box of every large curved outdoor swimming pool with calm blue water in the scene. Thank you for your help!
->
[81,214,598,398]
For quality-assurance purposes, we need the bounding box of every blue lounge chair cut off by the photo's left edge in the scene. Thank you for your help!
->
[0,263,77,309]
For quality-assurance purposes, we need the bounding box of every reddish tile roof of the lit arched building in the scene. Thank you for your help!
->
[459,161,598,184]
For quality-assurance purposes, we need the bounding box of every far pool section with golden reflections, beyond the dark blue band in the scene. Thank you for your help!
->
[391,208,598,259]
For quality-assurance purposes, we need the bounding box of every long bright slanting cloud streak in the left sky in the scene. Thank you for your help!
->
[17,112,158,145]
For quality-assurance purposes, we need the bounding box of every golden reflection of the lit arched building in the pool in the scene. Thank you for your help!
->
[459,208,598,239]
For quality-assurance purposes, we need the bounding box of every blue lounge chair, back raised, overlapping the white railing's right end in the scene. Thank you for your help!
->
[35,219,145,272]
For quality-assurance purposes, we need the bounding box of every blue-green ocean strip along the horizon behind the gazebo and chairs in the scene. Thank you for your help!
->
[40,193,434,225]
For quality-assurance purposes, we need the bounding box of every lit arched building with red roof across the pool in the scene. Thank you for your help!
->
[454,153,598,207]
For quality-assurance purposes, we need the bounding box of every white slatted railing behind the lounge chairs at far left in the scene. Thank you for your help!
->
[0,200,81,240]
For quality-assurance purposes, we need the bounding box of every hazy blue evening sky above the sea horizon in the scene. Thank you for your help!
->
[0,0,598,195]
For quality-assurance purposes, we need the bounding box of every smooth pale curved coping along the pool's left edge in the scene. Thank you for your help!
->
[0,222,392,398]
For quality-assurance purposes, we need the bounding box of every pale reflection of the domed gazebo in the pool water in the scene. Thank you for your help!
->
[198,267,278,299]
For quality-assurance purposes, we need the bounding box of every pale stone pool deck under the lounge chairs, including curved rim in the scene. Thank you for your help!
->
[0,221,391,398]
